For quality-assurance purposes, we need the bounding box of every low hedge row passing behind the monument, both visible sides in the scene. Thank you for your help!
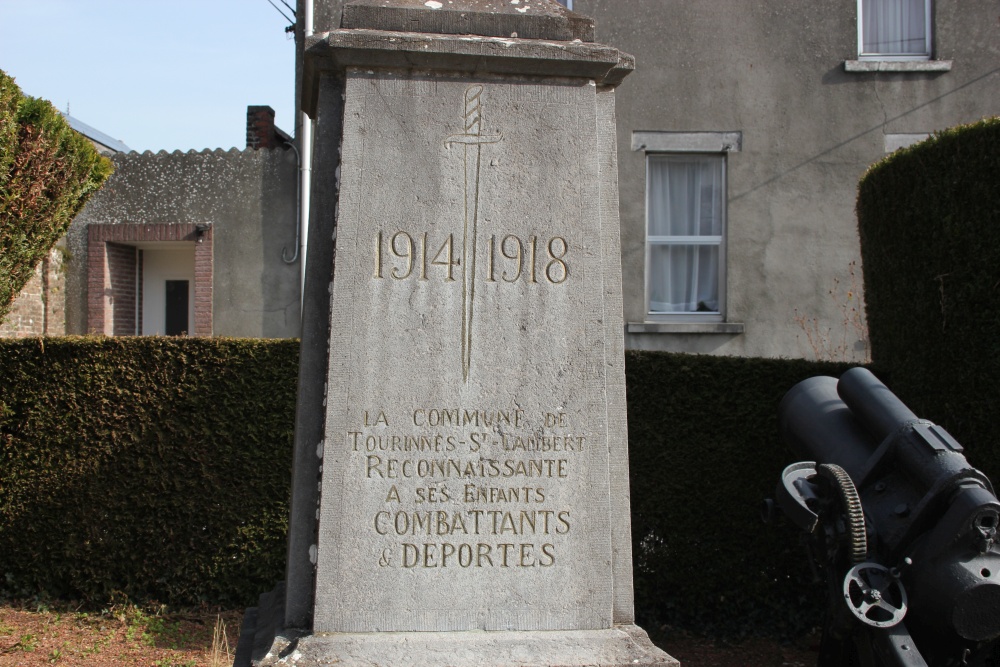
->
[0,338,843,634]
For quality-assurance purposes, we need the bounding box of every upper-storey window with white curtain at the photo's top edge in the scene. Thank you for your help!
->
[858,0,931,60]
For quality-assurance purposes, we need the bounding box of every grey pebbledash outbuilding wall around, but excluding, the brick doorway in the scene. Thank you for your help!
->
[66,149,300,338]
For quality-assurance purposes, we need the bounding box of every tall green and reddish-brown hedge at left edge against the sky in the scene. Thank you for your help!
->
[0,71,113,321]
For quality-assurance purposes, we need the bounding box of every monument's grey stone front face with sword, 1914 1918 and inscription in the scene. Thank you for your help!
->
[313,71,624,632]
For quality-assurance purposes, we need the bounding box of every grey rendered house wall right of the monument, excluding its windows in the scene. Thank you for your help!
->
[574,0,1000,359]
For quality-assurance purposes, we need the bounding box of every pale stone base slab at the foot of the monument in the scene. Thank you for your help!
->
[248,625,680,667]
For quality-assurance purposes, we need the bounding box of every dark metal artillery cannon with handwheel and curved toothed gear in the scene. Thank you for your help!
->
[765,368,1000,667]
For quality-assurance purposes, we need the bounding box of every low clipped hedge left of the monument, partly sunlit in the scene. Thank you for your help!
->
[0,337,298,606]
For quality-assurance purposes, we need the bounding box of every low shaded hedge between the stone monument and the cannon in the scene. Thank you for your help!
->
[626,352,849,637]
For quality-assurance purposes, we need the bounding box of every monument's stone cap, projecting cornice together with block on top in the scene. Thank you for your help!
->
[302,0,635,118]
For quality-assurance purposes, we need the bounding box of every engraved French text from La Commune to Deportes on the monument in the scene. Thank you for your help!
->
[345,407,587,571]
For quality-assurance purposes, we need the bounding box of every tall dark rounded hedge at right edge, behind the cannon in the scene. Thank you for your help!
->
[857,118,1000,470]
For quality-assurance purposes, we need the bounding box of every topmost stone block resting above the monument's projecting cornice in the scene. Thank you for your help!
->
[341,0,594,42]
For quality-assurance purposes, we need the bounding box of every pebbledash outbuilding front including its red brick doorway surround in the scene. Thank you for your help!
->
[66,148,300,338]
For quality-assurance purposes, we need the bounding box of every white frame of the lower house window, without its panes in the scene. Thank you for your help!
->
[643,154,729,323]
